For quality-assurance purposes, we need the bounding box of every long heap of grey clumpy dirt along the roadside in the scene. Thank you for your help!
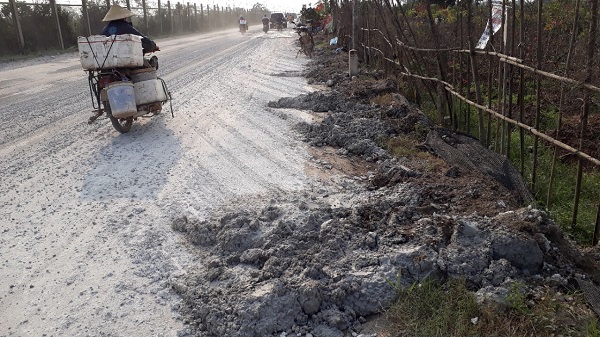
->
[169,40,597,337]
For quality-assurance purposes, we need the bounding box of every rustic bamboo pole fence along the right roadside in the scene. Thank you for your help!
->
[327,0,600,245]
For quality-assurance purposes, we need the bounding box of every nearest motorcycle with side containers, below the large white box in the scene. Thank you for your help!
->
[86,50,174,133]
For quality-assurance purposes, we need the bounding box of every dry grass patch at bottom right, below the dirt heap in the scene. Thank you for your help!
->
[385,279,600,337]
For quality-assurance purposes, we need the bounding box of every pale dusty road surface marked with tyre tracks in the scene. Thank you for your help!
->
[0,30,311,336]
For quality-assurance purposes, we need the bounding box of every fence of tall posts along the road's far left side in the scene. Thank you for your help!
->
[0,0,265,51]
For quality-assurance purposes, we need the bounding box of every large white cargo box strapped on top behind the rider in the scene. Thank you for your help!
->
[77,34,144,70]
